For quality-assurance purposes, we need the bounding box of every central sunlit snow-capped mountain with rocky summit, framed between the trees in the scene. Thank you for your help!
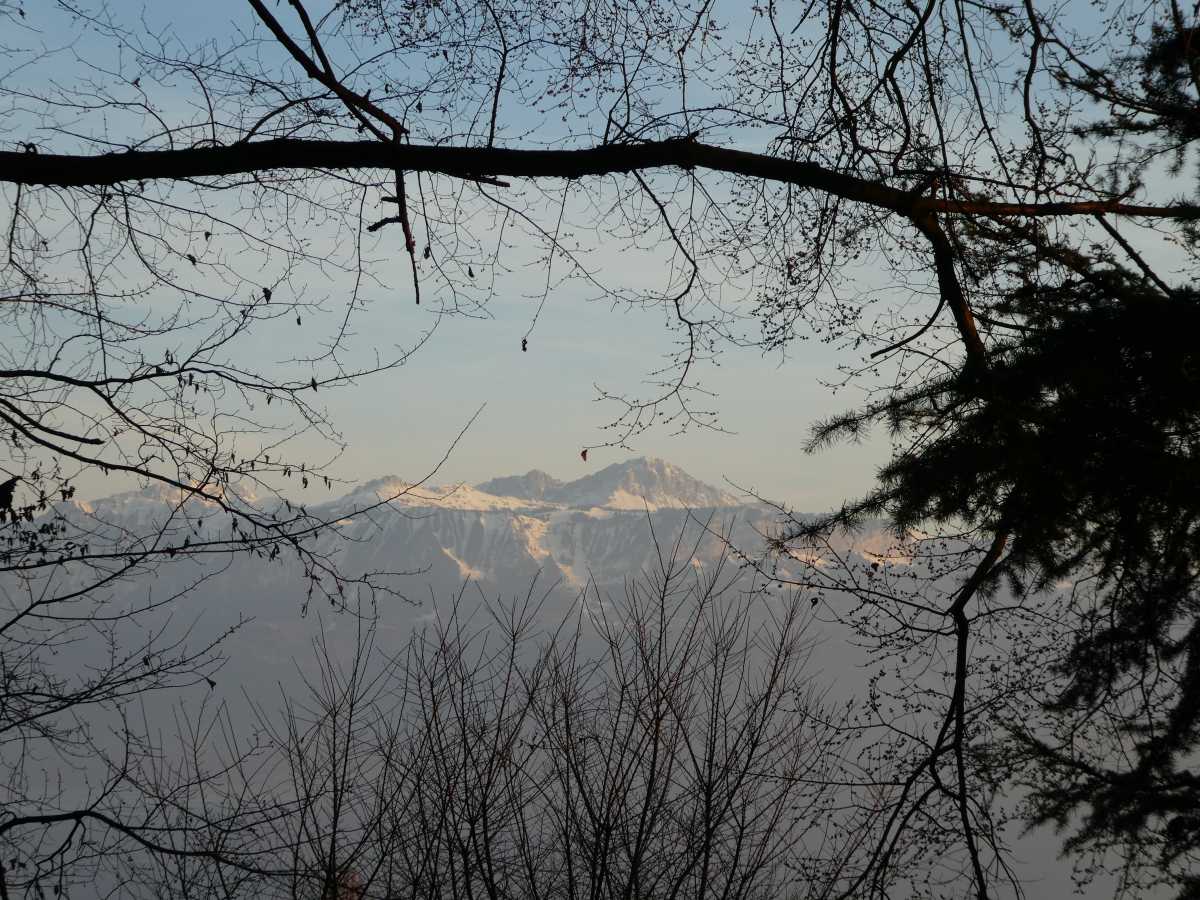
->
[326,458,766,602]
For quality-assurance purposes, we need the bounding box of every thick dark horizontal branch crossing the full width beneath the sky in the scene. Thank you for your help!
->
[0,138,1200,220]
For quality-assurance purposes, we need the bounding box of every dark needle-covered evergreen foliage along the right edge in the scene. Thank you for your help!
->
[793,19,1200,898]
